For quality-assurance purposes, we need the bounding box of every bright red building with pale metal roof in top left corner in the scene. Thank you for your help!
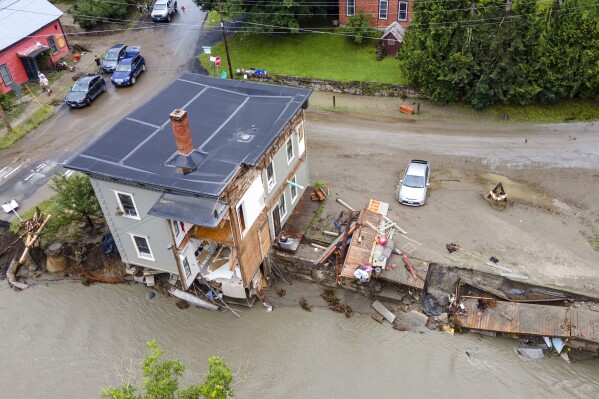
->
[0,0,69,93]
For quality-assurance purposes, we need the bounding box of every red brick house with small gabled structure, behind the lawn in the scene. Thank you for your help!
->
[339,0,412,55]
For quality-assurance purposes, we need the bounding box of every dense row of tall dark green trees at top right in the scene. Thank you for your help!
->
[398,0,599,108]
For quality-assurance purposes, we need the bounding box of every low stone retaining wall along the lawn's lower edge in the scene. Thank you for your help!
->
[248,74,422,99]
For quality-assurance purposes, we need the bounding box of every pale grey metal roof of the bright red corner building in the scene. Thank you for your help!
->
[0,0,62,50]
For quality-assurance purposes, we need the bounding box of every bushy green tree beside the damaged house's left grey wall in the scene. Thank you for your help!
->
[50,173,101,227]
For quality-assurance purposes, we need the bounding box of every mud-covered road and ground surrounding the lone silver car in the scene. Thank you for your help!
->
[307,109,599,295]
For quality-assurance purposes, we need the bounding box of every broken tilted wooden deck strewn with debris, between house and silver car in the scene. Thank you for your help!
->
[341,209,383,279]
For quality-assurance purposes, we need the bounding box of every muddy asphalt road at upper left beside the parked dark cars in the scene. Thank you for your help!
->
[0,0,222,220]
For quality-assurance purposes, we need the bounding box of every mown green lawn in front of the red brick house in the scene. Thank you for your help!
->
[199,33,405,83]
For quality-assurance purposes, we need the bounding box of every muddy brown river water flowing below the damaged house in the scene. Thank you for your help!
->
[0,281,599,398]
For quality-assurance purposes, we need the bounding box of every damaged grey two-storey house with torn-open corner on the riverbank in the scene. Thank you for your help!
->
[66,74,311,300]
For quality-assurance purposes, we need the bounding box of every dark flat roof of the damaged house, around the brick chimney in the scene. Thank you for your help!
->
[65,73,311,197]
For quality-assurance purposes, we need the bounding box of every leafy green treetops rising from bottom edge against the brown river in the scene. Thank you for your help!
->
[101,340,234,399]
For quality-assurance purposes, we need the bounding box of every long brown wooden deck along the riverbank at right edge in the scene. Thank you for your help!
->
[459,299,599,343]
